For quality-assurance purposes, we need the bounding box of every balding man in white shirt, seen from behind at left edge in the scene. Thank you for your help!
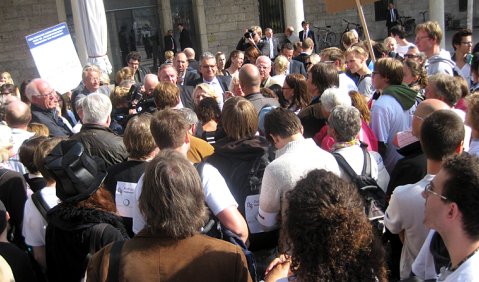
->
[5,100,34,174]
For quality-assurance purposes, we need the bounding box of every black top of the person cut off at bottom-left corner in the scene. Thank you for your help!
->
[0,242,37,282]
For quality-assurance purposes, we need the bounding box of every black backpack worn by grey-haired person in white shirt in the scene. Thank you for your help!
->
[333,147,386,230]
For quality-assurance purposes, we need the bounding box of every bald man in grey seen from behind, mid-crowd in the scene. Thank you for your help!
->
[239,64,279,113]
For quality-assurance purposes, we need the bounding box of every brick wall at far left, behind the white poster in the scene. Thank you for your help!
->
[0,0,58,85]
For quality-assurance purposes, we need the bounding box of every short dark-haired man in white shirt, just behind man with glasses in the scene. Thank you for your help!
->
[384,110,464,279]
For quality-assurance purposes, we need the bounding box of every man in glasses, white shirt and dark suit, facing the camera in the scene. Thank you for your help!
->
[194,52,231,108]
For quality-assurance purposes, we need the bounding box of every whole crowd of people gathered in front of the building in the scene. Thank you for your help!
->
[0,17,479,282]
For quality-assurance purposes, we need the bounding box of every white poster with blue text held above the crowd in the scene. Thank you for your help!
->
[25,23,82,93]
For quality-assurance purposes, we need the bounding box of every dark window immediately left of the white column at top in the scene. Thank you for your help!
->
[258,0,289,33]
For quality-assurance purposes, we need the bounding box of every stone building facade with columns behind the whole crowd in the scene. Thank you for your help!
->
[0,0,479,84]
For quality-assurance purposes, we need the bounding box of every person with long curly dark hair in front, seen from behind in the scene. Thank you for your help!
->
[265,170,387,282]
